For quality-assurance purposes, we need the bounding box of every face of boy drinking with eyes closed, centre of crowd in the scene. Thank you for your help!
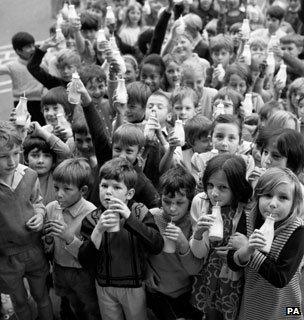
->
[146,95,169,128]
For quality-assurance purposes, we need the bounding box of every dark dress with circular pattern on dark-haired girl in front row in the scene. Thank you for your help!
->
[192,206,244,320]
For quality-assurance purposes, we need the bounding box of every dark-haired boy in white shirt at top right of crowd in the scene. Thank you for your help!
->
[250,6,286,43]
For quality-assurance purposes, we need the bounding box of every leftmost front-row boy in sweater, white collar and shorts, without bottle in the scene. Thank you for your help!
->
[0,121,53,320]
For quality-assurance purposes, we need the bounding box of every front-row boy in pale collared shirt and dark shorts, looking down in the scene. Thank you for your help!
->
[44,158,99,320]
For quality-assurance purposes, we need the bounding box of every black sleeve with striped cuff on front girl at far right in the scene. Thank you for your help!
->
[249,227,304,288]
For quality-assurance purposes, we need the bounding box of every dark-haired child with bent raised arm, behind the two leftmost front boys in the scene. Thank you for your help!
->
[23,122,71,205]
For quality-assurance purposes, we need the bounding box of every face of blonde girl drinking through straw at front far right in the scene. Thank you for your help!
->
[259,181,295,222]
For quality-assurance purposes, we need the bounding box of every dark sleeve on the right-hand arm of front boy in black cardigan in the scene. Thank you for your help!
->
[124,210,164,255]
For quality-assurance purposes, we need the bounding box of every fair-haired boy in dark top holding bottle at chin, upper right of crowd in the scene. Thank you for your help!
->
[205,34,234,89]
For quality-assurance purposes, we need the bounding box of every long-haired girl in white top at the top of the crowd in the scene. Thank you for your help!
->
[118,2,143,46]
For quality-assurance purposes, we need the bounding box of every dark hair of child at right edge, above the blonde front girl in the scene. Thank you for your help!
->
[256,128,304,174]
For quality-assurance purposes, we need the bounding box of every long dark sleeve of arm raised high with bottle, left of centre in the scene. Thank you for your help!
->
[83,103,112,167]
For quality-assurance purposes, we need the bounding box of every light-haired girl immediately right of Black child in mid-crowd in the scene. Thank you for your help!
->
[163,54,181,92]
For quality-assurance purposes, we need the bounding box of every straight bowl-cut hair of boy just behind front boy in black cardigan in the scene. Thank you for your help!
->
[112,123,145,149]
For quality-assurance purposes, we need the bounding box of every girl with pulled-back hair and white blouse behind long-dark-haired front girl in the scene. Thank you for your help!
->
[191,114,254,182]
